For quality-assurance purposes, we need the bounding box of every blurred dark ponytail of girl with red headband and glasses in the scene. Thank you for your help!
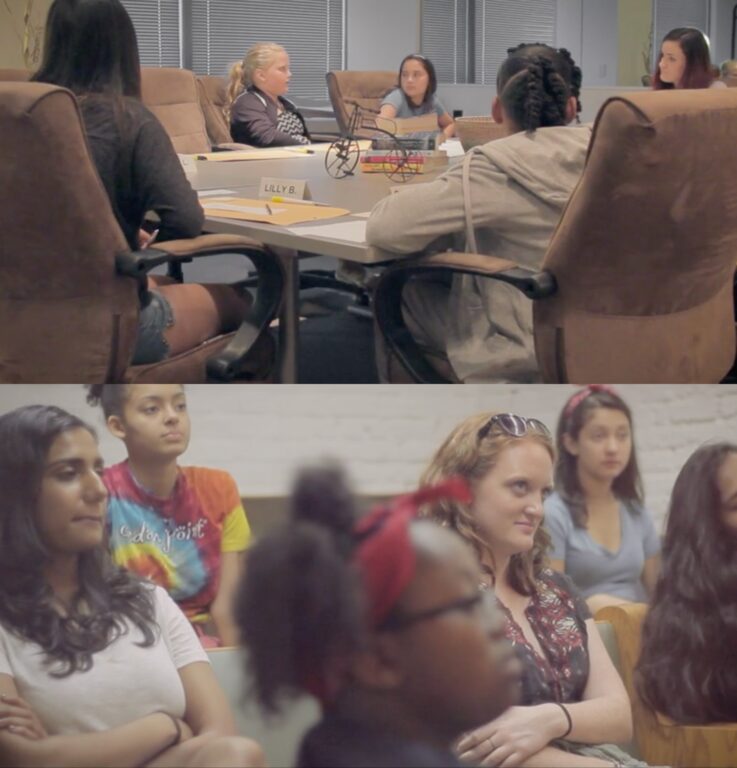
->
[235,466,366,713]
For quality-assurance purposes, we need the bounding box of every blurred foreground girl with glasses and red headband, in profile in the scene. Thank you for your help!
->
[236,468,519,768]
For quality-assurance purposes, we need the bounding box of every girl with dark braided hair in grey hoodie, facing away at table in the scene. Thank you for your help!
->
[366,43,591,382]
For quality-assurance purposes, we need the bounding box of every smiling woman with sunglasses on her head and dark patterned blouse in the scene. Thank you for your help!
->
[422,413,641,768]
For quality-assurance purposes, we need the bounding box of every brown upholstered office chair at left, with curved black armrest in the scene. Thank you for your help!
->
[0,83,283,382]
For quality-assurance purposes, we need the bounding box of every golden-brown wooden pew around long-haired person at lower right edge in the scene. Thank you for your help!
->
[596,603,737,768]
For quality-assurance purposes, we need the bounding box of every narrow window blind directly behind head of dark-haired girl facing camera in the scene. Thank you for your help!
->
[420,0,473,84]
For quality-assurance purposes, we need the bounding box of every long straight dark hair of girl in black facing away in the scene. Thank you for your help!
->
[33,0,141,99]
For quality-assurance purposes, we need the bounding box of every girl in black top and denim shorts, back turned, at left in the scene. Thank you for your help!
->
[33,0,249,364]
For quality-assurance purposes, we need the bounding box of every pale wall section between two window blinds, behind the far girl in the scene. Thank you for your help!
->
[346,0,420,70]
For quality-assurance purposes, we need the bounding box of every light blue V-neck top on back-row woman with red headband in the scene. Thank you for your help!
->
[545,493,660,602]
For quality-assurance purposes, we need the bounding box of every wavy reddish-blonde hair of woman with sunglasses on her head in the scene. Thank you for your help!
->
[420,412,555,595]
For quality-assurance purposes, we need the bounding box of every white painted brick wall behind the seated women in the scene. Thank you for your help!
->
[0,384,737,527]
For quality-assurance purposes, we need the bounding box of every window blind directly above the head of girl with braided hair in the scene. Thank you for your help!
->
[474,0,558,85]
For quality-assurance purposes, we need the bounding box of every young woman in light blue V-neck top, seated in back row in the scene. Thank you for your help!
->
[545,384,660,613]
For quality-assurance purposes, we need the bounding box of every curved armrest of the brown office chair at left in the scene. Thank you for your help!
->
[115,235,284,381]
